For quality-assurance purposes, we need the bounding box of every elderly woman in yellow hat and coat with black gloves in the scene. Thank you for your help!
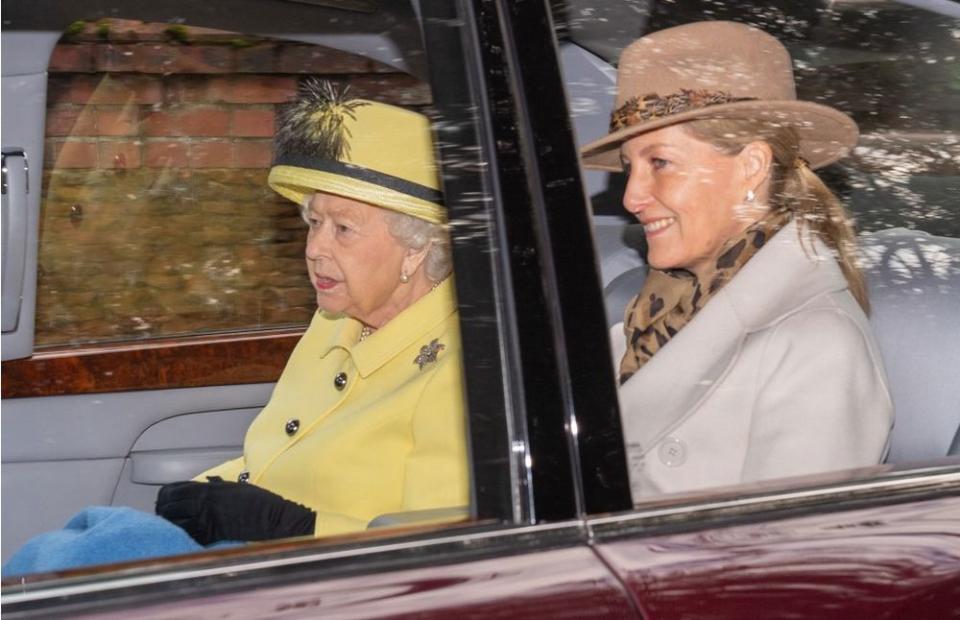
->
[156,82,468,544]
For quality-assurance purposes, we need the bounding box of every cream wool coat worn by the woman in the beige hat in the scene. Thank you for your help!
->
[611,222,893,502]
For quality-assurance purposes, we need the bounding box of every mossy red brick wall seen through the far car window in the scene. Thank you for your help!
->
[37,20,430,345]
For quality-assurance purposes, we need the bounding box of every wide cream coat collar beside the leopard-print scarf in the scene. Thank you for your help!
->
[620,221,847,453]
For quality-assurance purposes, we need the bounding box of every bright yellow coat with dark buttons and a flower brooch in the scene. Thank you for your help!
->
[197,278,469,536]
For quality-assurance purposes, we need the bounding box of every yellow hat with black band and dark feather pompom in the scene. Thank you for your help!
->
[267,80,447,224]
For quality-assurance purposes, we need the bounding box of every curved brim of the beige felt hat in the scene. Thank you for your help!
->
[580,101,860,172]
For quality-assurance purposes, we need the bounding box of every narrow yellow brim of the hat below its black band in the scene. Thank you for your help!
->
[267,165,447,224]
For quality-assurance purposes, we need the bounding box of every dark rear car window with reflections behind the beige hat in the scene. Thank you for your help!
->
[791,2,960,237]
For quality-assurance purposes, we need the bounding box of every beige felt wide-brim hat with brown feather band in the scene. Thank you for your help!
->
[580,21,859,171]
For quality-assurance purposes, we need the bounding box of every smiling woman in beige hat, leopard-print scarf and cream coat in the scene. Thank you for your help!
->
[583,22,893,500]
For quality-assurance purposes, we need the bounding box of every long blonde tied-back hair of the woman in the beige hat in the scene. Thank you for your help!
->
[682,119,870,314]
